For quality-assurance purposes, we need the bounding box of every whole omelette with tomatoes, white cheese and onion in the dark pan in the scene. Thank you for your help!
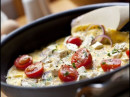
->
[6,24,129,87]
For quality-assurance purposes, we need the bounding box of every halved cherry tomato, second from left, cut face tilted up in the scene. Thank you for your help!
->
[25,62,44,78]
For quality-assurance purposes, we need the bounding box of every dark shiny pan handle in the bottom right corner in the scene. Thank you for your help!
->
[76,67,129,97]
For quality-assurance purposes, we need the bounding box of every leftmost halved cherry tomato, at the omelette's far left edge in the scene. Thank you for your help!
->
[14,55,33,70]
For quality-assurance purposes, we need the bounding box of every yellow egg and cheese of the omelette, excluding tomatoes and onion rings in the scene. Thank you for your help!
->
[6,25,129,87]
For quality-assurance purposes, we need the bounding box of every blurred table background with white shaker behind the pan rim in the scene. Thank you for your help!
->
[1,0,129,36]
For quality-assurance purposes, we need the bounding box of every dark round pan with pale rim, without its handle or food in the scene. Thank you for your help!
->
[1,3,129,97]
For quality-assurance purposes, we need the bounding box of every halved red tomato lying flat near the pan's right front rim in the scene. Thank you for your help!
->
[101,59,121,72]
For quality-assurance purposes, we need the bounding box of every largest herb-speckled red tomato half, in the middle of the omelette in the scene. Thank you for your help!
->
[71,48,92,69]
